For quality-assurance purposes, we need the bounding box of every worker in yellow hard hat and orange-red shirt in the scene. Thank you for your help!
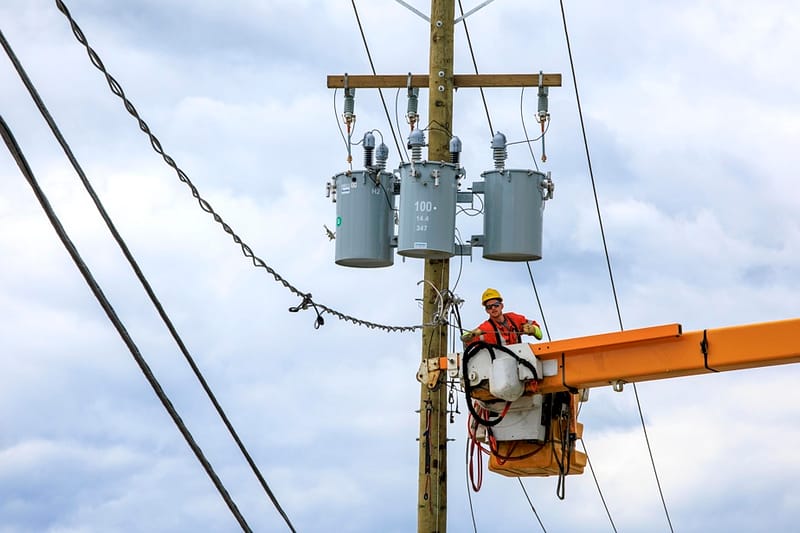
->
[461,288,542,344]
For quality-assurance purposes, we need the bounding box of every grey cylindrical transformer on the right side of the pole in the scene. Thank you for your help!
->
[481,170,547,261]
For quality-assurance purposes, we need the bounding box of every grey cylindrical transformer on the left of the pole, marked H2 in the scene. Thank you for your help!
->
[333,170,395,268]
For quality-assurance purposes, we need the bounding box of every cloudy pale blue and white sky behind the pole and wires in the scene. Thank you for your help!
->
[0,0,800,533]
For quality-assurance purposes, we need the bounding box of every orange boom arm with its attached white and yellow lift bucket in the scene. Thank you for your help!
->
[417,318,800,476]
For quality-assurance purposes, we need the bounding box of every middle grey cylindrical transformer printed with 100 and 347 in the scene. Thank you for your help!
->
[397,161,459,259]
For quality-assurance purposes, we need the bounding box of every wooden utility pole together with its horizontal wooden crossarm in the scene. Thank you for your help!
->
[327,0,561,533]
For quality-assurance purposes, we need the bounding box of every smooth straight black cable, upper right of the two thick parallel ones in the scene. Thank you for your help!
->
[0,30,294,531]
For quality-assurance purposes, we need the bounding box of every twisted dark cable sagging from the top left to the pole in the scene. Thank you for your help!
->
[56,0,425,332]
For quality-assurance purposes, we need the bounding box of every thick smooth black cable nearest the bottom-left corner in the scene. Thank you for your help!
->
[0,116,252,532]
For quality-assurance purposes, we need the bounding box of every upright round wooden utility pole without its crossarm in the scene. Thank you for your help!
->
[417,0,455,533]
